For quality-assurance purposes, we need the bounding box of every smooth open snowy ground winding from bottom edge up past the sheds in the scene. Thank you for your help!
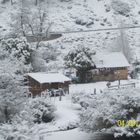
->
[34,80,139,140]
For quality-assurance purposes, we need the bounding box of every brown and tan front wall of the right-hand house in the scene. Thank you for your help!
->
[85,68,128,82]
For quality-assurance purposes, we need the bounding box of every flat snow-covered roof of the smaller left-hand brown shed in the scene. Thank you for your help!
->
[27,72,71,84]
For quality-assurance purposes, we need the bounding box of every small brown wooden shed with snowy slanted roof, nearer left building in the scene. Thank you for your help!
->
[27,72,71,96]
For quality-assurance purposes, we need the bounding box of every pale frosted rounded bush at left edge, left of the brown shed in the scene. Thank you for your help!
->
[0,73,26,123]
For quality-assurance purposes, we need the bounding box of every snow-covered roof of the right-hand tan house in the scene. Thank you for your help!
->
[93,52,130,68]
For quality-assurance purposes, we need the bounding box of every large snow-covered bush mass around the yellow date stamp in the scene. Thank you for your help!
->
[80,88,140,136]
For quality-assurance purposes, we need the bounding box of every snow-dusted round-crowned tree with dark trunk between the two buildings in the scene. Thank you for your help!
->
[64,46,95,82]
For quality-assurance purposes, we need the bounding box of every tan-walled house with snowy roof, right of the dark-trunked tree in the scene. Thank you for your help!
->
[85,52,130,82]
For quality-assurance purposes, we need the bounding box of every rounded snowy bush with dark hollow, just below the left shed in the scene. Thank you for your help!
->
[14,97,56,123]
